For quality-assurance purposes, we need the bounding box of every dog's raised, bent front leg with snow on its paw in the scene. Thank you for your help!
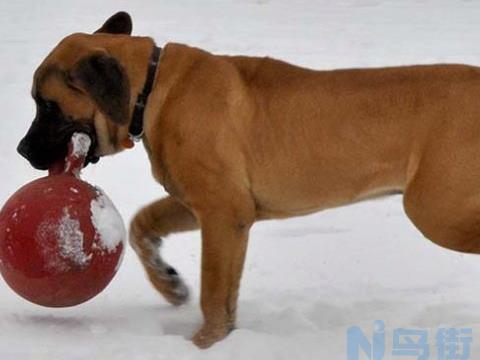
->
[130,196,198,305]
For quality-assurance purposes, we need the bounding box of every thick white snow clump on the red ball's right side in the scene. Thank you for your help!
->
[90,189,126,253]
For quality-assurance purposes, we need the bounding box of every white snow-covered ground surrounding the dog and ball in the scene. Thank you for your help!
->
[0,0,480,360]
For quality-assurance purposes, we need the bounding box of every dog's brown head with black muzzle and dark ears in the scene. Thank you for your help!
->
[17,12,137,170]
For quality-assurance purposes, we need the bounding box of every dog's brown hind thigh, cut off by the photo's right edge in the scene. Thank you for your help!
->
[404,135,480,254]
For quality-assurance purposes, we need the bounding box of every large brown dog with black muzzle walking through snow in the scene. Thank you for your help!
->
[19,13,480,347]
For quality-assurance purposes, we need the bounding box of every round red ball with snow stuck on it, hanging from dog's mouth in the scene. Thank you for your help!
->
[0,134,125,307]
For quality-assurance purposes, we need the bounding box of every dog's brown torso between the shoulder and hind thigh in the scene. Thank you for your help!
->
[212,52,480,218]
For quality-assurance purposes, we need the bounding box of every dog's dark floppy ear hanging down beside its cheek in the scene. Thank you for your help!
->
[68,52,130,124]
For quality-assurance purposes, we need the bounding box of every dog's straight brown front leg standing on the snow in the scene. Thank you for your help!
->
[193,194,255,348]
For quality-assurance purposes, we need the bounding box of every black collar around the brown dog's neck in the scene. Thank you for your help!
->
[128,45,162,141]
